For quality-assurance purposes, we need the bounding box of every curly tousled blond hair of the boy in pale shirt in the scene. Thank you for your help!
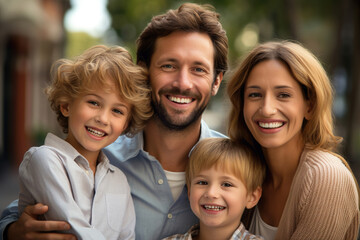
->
[45,45,152,136]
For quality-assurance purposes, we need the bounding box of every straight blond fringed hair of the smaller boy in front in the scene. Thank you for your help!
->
[186,138,265,193]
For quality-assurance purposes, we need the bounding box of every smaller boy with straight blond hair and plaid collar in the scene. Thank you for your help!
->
[166,138,265,240]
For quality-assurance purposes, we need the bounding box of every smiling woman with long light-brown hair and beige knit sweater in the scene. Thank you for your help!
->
[227,41,360,240]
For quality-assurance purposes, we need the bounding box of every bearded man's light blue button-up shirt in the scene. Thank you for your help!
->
[0,121,225,240]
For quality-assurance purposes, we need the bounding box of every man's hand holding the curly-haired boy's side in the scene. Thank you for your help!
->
[5,203,76,240]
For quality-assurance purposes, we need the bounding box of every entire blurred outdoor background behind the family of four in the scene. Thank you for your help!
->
[0,0,360,218]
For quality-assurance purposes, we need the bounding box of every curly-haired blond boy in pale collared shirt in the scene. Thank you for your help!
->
[19,46,152,240]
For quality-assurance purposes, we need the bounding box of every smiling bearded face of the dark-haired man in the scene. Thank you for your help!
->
[149,32,222,130]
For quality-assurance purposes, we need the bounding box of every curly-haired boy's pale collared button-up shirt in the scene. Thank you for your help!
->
[19,133,135,240]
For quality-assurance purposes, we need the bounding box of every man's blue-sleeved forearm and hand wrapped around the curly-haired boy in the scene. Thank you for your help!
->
[0,200,76,240]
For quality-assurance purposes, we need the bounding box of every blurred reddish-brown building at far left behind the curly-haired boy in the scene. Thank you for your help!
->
[0,0,70,211]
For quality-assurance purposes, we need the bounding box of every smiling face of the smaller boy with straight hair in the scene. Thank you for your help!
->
[189,167,253,230]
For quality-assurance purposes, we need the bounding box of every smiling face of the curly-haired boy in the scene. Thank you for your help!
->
[61,80,131,158]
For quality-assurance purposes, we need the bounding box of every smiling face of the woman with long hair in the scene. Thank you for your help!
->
[244,60,310,149]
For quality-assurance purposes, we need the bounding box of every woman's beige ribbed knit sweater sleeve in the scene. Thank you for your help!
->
[279,151,359,240]
